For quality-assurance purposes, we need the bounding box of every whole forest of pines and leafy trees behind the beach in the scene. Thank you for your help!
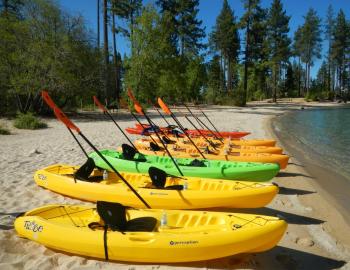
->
[0,0,350,115]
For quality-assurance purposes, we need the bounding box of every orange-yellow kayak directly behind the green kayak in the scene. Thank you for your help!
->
[134,140,289,169]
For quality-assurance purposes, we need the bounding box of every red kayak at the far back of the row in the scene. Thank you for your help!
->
[125,123,250,139]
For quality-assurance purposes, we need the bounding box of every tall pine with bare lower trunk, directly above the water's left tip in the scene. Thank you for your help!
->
[268,0,291,102]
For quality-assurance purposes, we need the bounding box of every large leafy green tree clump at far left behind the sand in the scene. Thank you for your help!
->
[0,0,101,113]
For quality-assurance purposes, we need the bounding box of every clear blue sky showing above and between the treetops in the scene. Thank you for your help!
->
[58,0,350,77]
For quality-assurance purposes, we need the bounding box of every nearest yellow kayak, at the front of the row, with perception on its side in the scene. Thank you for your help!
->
[15,202,287,263]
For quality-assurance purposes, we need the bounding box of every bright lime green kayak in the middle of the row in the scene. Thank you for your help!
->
[89,150,279,181]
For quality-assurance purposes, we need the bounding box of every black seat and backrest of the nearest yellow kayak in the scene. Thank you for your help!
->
[97,201,158,232]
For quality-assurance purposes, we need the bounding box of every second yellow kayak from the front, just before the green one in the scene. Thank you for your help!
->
[34,164,278,209]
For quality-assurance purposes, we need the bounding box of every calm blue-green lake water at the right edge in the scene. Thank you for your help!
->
[275,108,350,179]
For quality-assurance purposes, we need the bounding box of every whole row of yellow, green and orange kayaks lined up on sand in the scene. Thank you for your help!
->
[15,92,288,263]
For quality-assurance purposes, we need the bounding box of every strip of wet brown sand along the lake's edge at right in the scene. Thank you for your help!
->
[266,107,350,253]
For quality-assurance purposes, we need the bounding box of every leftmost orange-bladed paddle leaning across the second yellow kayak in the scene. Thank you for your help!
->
[41,91,151,208]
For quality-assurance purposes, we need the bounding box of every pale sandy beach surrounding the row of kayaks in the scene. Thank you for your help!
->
[0,101,350,270]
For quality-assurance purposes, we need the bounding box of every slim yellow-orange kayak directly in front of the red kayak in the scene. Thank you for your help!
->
[150,134,276,147]
